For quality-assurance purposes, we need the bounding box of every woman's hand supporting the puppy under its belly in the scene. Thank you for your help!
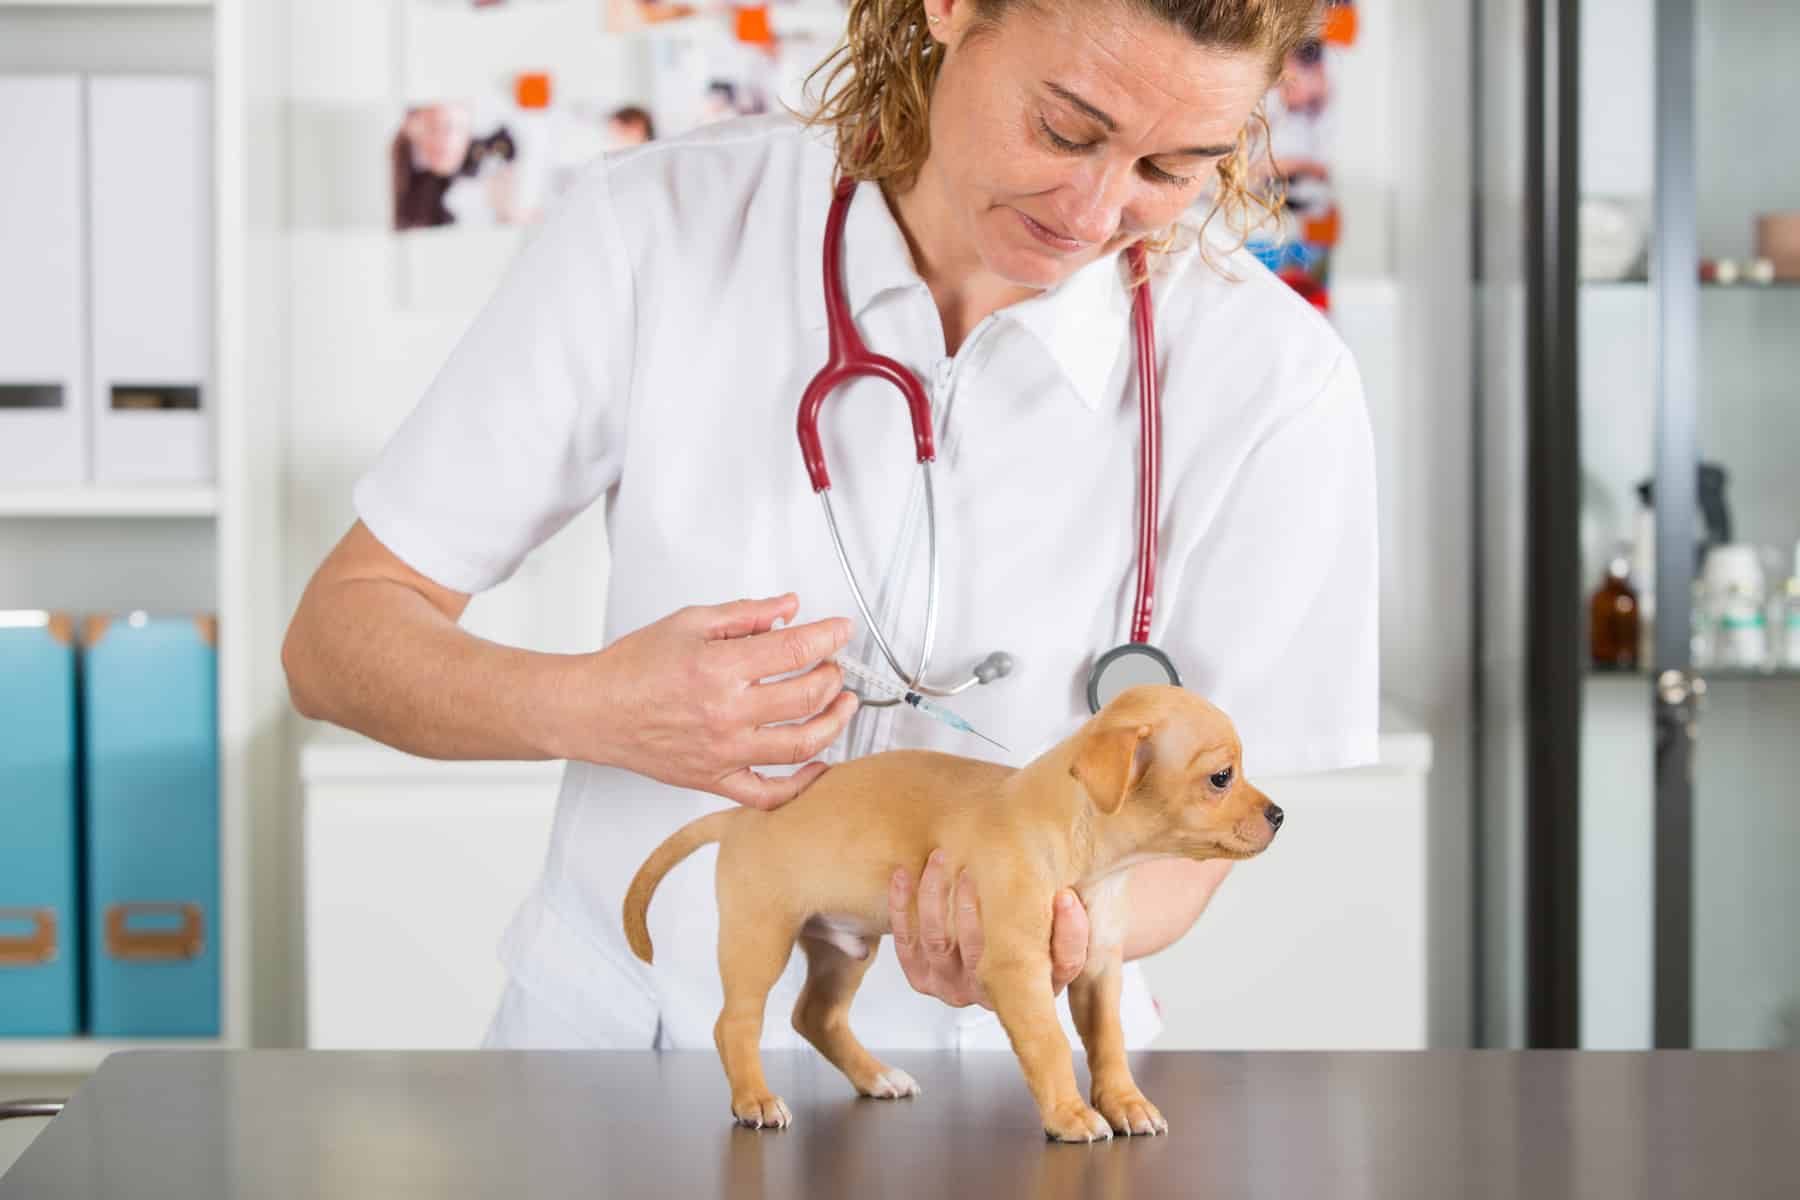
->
[887,851,1087,1009]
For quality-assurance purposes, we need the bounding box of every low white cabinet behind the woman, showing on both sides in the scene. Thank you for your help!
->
[301,720,1431,1049]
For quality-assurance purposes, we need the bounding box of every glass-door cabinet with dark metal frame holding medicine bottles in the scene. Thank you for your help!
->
[1478,0,1800,1051]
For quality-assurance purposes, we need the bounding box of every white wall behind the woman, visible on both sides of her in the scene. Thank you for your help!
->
[265,0,1471,1045]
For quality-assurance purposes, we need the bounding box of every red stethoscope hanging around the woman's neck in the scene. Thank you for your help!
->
[799,178,1181,712]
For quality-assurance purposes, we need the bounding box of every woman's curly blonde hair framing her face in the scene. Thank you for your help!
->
[799,0,1323,275]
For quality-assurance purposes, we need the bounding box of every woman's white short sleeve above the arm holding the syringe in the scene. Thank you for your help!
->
[353,160,635,592]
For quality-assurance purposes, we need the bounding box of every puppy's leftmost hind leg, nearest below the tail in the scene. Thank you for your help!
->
[713,906,799,1130]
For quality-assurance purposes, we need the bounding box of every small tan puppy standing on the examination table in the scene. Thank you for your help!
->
[625,685,1282,1142]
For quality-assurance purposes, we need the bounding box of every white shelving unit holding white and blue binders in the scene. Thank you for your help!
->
[0,0,288,1078]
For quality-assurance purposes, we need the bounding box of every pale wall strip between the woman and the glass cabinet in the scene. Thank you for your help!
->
[1334,0,1474,1045]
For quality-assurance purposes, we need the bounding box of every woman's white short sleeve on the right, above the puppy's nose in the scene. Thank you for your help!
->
[1165,351,1381,775]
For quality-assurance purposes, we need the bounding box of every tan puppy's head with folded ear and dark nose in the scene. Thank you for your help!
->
[1069,684,1282,858]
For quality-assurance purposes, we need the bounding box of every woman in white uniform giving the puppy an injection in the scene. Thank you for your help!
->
[283,0,1377,1047]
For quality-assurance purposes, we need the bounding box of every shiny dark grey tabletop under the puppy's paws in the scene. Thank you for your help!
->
[0,1051,1800,1200]
